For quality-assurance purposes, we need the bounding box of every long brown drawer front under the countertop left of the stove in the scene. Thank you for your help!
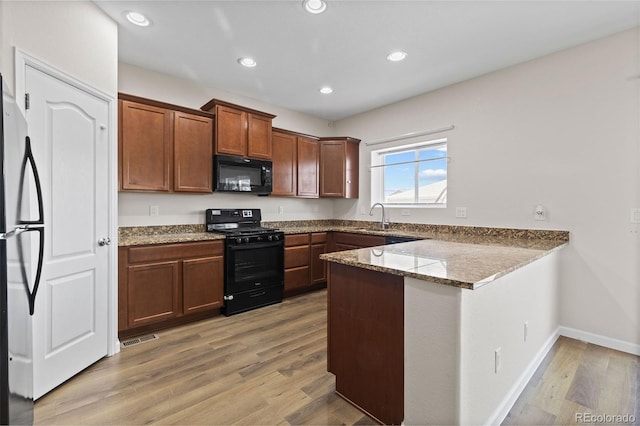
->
[129,241,224,263]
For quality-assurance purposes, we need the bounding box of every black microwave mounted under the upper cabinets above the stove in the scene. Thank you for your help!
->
[213,155,273,195]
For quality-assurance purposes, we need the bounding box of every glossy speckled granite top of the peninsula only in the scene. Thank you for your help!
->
[320,237,568,290]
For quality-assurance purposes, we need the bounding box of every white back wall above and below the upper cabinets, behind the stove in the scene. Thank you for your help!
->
[118,64,334,226]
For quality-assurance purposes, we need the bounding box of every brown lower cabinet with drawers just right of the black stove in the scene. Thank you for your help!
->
[284,232,327,292]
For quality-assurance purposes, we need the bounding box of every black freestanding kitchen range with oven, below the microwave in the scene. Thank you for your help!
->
[205,209,284,316]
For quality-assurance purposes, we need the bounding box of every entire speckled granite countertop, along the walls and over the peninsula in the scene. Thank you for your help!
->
[118,220,569,289]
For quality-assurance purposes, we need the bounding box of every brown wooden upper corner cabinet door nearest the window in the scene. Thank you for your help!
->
[320,141,346,197]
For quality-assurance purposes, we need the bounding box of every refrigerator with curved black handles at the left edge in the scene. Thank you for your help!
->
[0,71,44,425]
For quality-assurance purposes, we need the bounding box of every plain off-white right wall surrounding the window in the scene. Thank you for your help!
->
[335,29,640,350]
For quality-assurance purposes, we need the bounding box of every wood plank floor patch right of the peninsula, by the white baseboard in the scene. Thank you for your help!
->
[503,336,640,425]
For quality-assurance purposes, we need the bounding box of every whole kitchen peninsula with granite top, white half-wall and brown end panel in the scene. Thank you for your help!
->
[321,232,568,424]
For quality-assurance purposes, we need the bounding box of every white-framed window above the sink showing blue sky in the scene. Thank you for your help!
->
[371,139,447,207]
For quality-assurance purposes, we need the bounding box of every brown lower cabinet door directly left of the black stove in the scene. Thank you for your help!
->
[182,256,224,315]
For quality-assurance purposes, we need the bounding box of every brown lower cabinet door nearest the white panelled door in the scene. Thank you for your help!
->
[127,261,181,327]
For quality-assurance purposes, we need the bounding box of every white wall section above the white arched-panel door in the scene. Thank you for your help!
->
[0,1,118,97]
